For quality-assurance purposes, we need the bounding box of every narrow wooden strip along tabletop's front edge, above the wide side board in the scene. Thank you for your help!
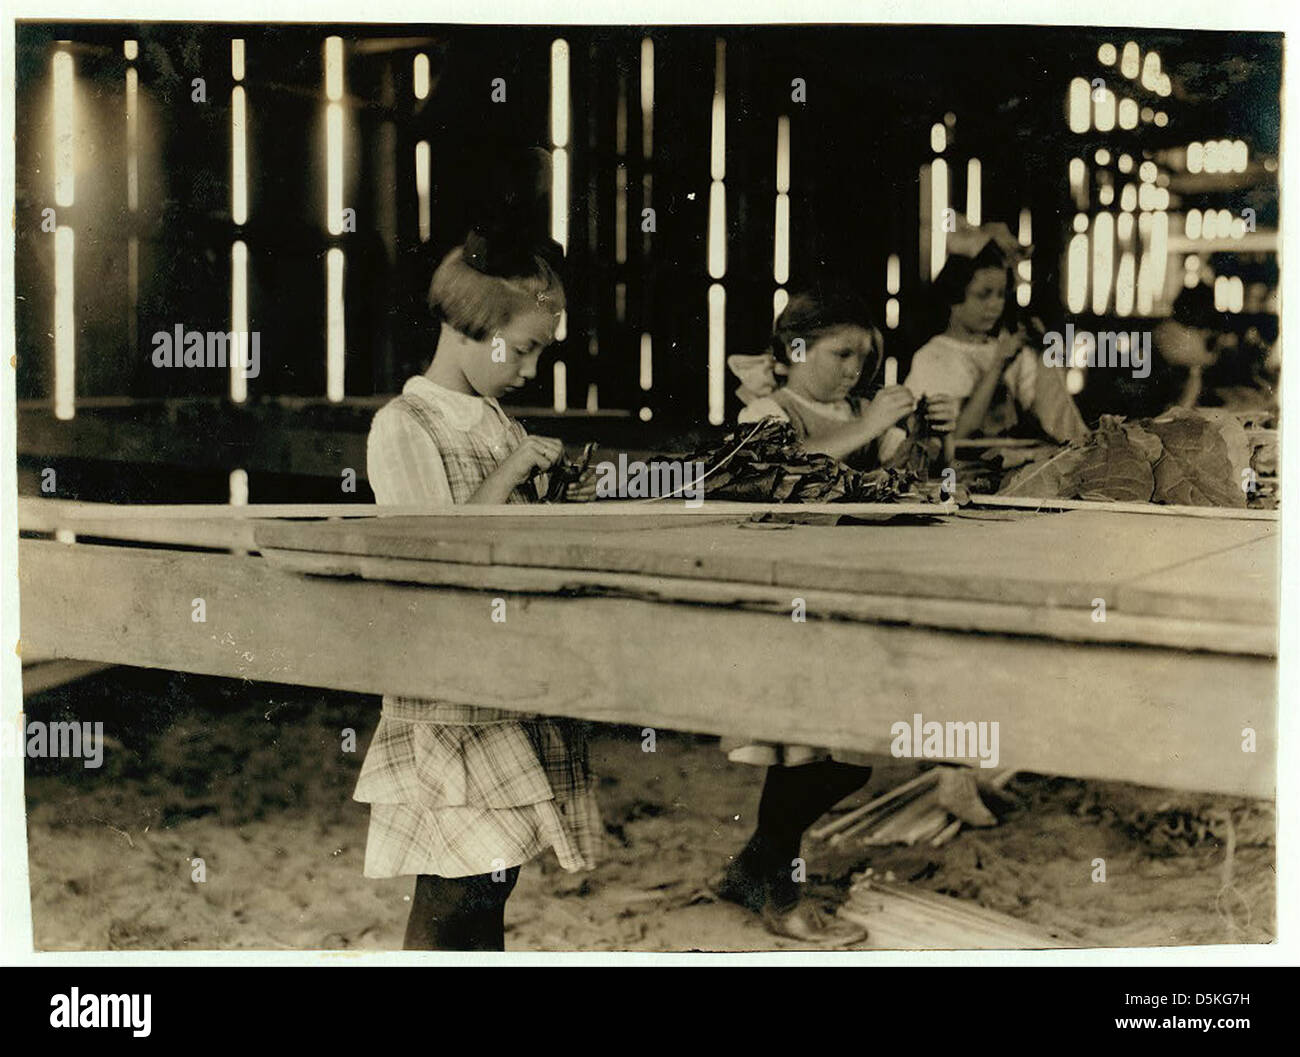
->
[261,547,1277,657]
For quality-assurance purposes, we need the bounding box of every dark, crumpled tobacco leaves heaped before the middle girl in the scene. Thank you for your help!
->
[673,419,922,503]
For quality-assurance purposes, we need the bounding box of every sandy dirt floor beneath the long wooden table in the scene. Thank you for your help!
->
[26,668,1275,950]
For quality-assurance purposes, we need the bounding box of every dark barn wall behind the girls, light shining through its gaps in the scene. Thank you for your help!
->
[16,23,1281,502]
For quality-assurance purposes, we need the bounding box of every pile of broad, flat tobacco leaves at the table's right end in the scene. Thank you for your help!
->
[998,408,1258,507]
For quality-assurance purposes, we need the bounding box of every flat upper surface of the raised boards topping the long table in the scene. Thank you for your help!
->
[248,511,1275,613]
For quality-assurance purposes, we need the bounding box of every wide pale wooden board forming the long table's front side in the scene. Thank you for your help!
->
[20,540,1277,797]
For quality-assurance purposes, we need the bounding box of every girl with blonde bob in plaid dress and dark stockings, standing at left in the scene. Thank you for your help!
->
[354,233,601,950]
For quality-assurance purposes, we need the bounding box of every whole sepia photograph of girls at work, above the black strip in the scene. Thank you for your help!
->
[0,5,1294,967]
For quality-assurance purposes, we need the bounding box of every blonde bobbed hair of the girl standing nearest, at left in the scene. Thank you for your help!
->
[429,246,564,342]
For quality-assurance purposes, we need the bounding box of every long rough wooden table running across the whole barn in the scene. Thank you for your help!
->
[20,501,1278,797]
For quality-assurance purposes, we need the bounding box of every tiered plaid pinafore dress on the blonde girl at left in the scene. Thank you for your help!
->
[354,394,602,878]
